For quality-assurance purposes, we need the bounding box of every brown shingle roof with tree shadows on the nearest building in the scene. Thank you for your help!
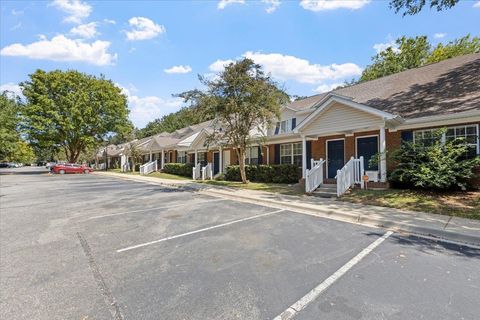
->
[290,53,480,119]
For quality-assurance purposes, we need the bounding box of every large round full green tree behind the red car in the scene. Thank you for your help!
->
[20,70,131,162]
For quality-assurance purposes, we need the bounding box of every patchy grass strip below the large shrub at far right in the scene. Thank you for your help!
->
[339,189,480,220]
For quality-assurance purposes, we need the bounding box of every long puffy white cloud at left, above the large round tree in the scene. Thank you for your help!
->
[0,35,117,66]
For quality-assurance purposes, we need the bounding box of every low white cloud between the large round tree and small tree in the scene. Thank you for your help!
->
[117,84,183,128]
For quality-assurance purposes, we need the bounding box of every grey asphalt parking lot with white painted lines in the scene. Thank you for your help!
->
[0,168,480,320]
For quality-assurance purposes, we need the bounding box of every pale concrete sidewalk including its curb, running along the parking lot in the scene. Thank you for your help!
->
[95,172,480,246]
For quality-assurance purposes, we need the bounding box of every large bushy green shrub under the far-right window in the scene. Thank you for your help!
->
[389,139,480,190]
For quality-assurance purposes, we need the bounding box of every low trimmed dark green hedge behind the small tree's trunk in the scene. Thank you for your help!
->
[225,164,302,183]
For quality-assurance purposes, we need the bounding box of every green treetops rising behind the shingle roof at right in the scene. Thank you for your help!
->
[358,35,480,82]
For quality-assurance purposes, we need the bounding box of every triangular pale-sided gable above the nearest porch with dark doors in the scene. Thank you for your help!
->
[301,103,384,135]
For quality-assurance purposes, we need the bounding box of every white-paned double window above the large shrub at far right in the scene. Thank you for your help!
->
[413,125,480,158]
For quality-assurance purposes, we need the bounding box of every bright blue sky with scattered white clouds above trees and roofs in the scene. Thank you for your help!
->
[0,0,480,127]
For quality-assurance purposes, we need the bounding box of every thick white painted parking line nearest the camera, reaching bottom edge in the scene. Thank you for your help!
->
[273,231,393,320]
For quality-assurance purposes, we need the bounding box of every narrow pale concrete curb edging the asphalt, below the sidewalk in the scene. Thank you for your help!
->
[93,172,480,247]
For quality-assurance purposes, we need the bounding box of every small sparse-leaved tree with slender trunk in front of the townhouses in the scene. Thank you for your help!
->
[184,59,288,183]
